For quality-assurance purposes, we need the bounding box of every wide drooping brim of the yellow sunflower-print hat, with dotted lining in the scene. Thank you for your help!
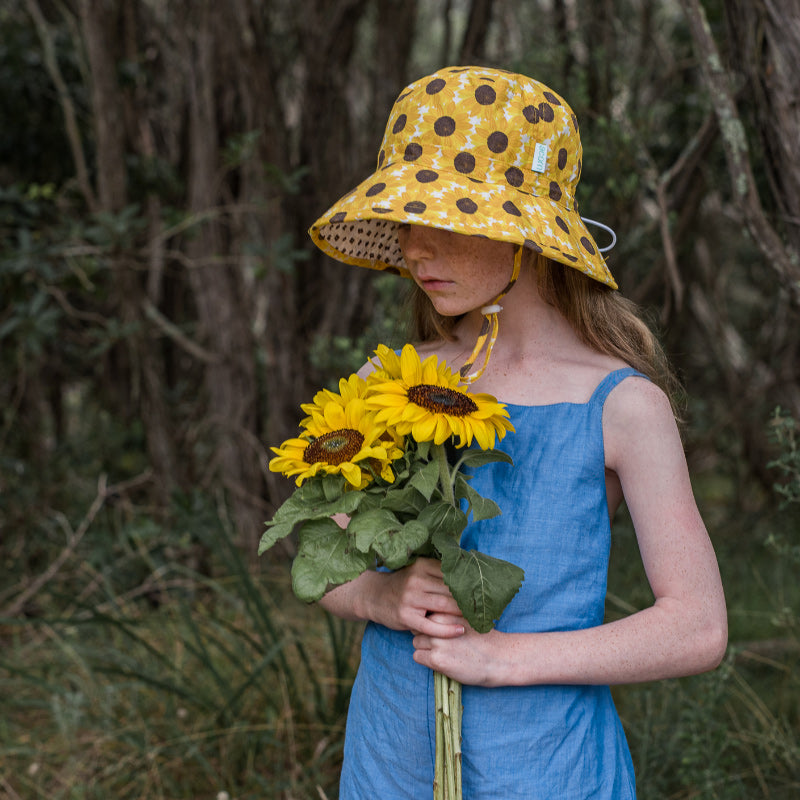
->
[309,160,617,289]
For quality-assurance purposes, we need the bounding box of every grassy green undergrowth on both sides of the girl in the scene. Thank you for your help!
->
[0,410,800,800]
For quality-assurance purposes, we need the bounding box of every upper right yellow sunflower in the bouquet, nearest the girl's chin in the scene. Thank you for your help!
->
[366,344,514,450]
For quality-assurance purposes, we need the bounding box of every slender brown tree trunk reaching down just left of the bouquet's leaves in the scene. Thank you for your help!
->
[184,0,264,551]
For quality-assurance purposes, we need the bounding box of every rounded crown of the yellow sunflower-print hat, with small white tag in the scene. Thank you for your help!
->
[378,67,582,209]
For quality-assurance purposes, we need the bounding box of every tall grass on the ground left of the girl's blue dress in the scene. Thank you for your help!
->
[0,490,358,800]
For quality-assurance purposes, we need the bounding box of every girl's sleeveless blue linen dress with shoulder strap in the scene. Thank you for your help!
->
[340,368,639,800]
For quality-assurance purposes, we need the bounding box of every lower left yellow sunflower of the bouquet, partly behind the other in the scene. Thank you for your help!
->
[269,397,403,489]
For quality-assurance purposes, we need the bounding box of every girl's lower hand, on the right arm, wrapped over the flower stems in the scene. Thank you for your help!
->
[413,614,504,686]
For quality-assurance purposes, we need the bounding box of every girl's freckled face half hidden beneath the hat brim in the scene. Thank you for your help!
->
[397,225,514,317]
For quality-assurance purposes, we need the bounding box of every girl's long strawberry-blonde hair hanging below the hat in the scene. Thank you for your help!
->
[409,250,682,416]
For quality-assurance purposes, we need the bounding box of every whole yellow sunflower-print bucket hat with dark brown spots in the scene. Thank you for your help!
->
[309,67,617,289]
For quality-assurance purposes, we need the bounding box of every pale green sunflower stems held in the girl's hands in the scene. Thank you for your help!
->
[433,445,462,800]
